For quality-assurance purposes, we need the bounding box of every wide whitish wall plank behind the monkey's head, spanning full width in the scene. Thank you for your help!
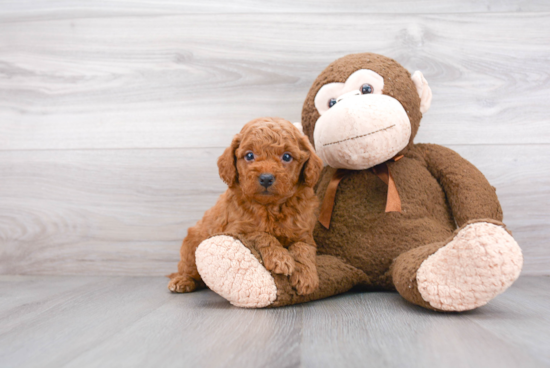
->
[0,13,550,150]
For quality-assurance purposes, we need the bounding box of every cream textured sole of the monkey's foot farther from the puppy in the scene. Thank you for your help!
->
[416,222,523,311]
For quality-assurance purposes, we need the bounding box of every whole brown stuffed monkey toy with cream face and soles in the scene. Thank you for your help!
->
[196,53,523,311]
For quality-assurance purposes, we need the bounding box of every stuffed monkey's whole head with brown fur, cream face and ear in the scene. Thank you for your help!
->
[302,54,431,170]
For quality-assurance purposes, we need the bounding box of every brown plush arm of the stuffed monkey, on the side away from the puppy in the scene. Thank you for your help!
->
[415,144,502,227]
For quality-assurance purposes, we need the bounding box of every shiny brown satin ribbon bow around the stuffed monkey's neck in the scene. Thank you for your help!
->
[319,155,403,229]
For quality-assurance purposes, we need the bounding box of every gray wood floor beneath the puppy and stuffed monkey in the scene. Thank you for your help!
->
[0,276,550,368]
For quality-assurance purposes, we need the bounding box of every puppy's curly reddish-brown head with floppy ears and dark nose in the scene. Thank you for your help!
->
[218,118,323,204]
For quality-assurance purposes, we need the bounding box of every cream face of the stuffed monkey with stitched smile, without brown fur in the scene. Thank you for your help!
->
[314,69,411,170]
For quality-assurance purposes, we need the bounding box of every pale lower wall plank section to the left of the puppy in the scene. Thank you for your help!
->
[0,149,225,275]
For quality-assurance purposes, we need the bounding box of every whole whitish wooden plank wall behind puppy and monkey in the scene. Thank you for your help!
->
[0,0,550,275]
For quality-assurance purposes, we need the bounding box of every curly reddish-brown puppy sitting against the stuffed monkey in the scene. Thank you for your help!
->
[168,118,323,295]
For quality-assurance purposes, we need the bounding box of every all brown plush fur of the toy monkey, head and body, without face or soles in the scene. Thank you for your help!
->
[275,53,512,309]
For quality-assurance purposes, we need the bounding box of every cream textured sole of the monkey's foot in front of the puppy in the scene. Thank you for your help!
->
[195,235,277,308]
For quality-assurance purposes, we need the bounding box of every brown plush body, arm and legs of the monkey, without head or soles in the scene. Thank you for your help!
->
[252,137,503,310]
